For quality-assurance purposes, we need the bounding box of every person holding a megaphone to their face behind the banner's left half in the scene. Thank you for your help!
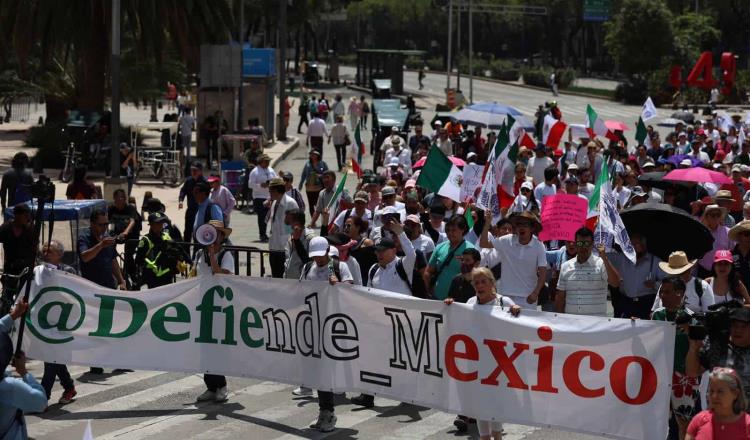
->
[193,220,234,402]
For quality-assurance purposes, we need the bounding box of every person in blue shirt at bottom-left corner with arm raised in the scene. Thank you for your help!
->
[0,302,47,440]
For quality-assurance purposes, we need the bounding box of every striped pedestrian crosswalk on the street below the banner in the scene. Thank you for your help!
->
[19,361,564,440]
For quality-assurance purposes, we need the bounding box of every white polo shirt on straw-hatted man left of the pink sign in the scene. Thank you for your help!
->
[492,234,547,298]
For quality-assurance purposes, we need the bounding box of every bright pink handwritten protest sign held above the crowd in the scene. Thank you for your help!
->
[539,194,589,241]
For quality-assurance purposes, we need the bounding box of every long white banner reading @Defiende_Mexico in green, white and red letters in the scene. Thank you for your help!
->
[24,270,675,440]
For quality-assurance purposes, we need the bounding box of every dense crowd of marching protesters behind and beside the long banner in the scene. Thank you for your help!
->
[0,102,750,440]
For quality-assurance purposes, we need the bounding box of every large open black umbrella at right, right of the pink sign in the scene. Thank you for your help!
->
[620,203,714,261]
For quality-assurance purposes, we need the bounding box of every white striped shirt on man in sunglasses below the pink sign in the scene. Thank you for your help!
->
[557,254,608,316]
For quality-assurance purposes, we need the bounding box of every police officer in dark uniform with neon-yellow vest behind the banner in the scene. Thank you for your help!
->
[135,212,186,289]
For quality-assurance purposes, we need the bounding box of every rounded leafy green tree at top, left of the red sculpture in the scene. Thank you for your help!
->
[604,0,674,75]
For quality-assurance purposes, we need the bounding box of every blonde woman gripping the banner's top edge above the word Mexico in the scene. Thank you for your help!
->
[443,267,521,440]
